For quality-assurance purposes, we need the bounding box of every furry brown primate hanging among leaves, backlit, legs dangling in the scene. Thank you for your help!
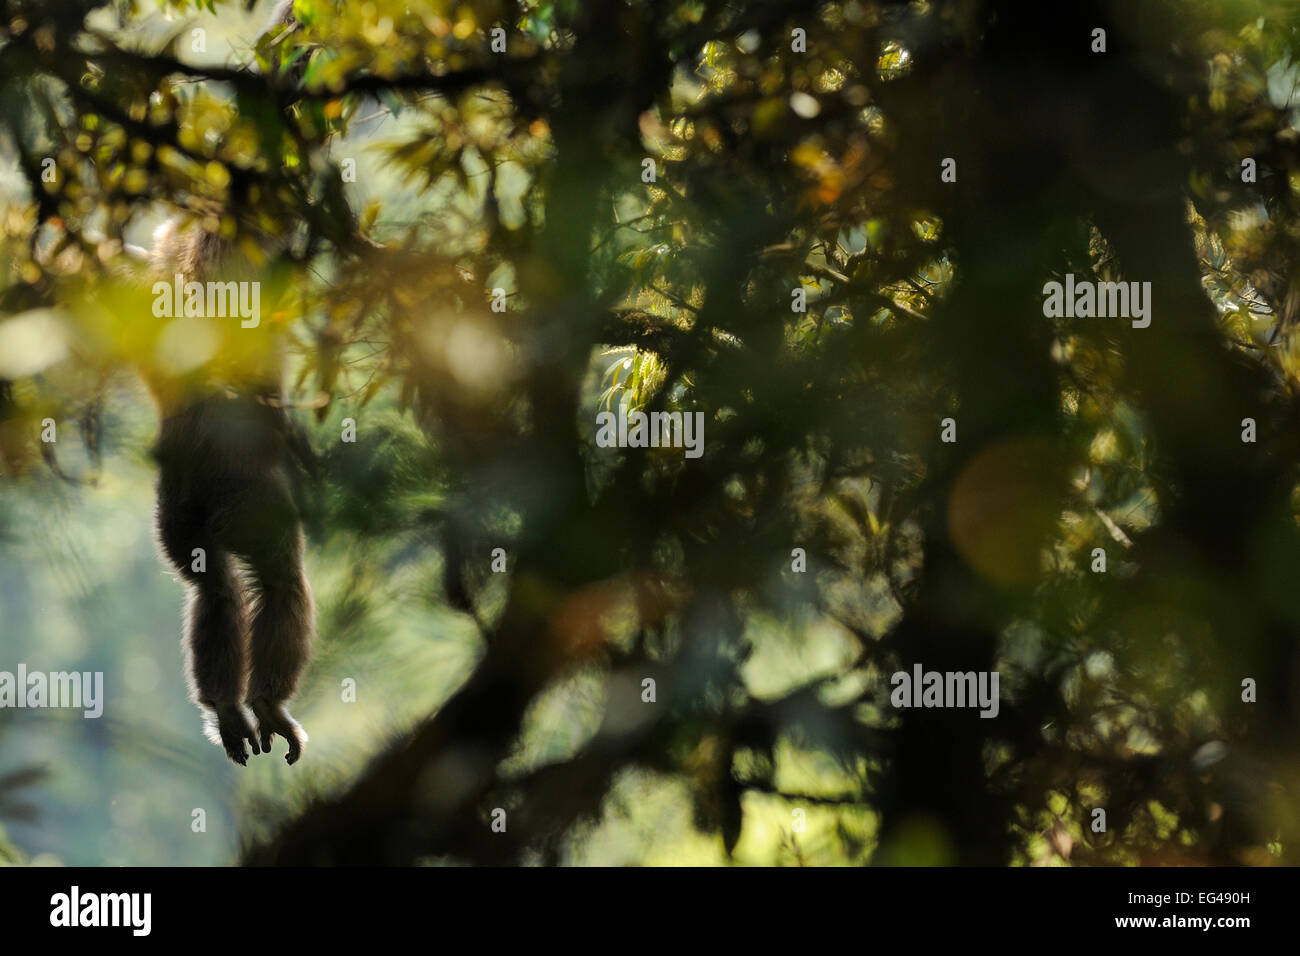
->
[146,0,316,766]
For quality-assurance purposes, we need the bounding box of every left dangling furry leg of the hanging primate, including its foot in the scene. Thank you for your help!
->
[157,475,260,766]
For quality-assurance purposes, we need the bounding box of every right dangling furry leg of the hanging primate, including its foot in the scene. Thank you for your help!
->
[239,486,316,763]
